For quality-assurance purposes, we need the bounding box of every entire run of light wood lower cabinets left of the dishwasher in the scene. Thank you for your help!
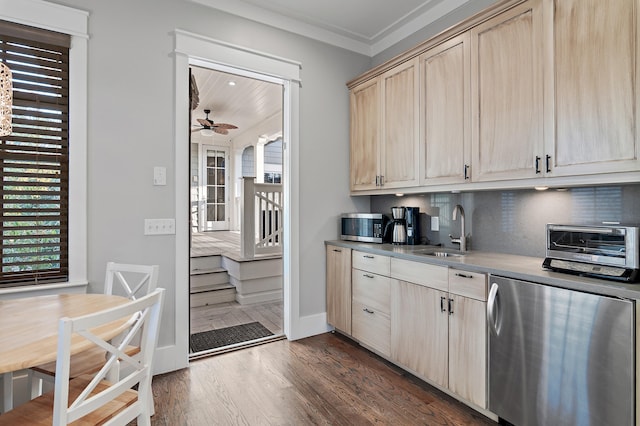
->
[327,250,487,409]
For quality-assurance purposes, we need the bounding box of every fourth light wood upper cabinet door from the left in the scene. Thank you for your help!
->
[471,0,543,181]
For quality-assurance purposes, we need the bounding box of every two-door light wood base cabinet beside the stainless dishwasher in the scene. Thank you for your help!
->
[391,264,487,408]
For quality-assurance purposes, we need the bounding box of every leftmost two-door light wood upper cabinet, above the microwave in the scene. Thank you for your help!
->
[350,58,419,191]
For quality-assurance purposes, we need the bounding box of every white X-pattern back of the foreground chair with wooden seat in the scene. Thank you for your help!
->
[53,288,164,425]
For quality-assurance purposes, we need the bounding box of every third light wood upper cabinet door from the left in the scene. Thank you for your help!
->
[420,33,471,185]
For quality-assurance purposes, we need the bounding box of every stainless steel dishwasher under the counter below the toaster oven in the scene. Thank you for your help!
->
[487,276,635,426]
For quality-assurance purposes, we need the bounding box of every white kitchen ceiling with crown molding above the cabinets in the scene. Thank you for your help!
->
[190,0,471,56]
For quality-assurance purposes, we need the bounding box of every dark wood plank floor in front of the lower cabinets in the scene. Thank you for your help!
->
[152,333,496,426]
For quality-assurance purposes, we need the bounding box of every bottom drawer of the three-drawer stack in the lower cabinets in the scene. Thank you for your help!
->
[351,300,391,357]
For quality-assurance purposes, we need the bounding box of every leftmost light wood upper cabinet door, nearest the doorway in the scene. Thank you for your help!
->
[350,79,380,191]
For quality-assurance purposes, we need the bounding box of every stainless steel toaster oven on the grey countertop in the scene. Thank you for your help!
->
[543,224,640,282]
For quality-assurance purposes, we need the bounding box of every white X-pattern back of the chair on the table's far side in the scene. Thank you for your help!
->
[104,262,159,300]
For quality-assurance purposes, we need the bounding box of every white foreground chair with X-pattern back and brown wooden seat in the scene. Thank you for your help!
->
[0,288,164,426]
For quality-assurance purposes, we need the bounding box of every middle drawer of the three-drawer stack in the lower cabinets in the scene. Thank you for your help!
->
[351,269,391,315]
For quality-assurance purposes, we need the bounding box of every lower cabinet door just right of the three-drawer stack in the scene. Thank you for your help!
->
[391,281,448,387]
